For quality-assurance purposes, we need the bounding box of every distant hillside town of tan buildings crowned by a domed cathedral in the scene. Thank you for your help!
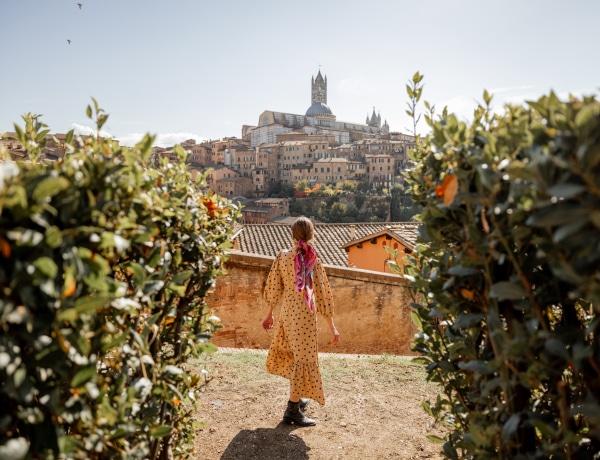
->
[0,70,415,205]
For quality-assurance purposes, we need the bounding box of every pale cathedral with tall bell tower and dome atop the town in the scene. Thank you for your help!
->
[247,70,390,147]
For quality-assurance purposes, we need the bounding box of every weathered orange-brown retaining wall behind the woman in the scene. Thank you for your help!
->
[207,251,417,355]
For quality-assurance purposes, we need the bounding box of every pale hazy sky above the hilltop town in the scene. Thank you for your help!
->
[0,0,600,145]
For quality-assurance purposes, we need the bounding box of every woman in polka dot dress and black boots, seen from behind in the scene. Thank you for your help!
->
[263,217,340,426]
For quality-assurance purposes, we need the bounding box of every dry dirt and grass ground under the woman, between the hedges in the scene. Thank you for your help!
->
[195,350,443,460]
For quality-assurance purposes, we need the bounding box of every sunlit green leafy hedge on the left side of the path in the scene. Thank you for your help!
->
[0,101,238,459]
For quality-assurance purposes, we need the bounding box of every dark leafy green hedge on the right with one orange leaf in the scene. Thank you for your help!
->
[398,93,600,459]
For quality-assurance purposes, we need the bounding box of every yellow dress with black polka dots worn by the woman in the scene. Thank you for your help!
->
[264,250,333,405]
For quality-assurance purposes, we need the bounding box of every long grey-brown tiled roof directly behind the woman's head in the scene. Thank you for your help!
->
[234,222,420,267]
